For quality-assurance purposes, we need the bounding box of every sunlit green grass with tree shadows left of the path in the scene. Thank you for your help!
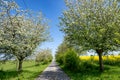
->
[0,61,49,80]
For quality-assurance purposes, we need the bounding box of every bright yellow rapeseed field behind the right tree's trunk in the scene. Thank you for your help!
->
[80,56,120,61]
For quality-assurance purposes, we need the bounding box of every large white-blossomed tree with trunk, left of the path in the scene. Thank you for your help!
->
[0,0,49,71]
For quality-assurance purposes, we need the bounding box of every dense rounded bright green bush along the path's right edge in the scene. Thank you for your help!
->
[64,49,80,71]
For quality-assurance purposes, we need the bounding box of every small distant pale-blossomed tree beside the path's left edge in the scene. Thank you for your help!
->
[35,49,53,64]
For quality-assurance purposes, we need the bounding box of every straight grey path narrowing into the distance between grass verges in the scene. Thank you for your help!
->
[36,60,70,80]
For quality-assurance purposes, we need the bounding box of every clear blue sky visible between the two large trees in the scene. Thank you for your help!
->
[15,0,66,54]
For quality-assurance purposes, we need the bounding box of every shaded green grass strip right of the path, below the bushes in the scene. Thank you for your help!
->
[61,62,120,80]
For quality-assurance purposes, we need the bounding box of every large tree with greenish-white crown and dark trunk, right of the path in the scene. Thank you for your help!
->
[60,0,120,71]
